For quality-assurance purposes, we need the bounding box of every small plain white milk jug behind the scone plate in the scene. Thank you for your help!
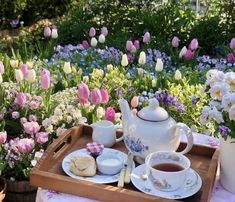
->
[90,120,123,147]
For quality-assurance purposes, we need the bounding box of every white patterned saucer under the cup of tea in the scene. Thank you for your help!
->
[131,164,202,199]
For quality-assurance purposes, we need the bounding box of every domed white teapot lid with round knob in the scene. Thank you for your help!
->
[137,98,169,122]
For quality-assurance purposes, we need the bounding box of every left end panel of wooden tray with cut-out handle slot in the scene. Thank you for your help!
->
[47,125,83,160]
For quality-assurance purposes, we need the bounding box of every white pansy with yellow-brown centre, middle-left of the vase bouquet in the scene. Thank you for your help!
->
[209,82,230,100]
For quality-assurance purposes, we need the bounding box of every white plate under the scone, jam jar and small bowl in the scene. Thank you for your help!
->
[62,148,135,184]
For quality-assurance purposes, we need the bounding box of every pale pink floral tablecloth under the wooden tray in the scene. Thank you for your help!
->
[36,133,235,202]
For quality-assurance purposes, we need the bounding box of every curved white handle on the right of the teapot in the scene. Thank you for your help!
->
[171,123,193,154]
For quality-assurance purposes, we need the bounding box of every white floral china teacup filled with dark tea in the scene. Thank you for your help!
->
[145,151,191,191]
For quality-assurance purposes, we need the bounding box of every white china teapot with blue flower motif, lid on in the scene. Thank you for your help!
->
[119,98,193,163]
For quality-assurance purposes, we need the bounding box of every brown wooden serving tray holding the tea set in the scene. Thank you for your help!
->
[30,125,219,202]
